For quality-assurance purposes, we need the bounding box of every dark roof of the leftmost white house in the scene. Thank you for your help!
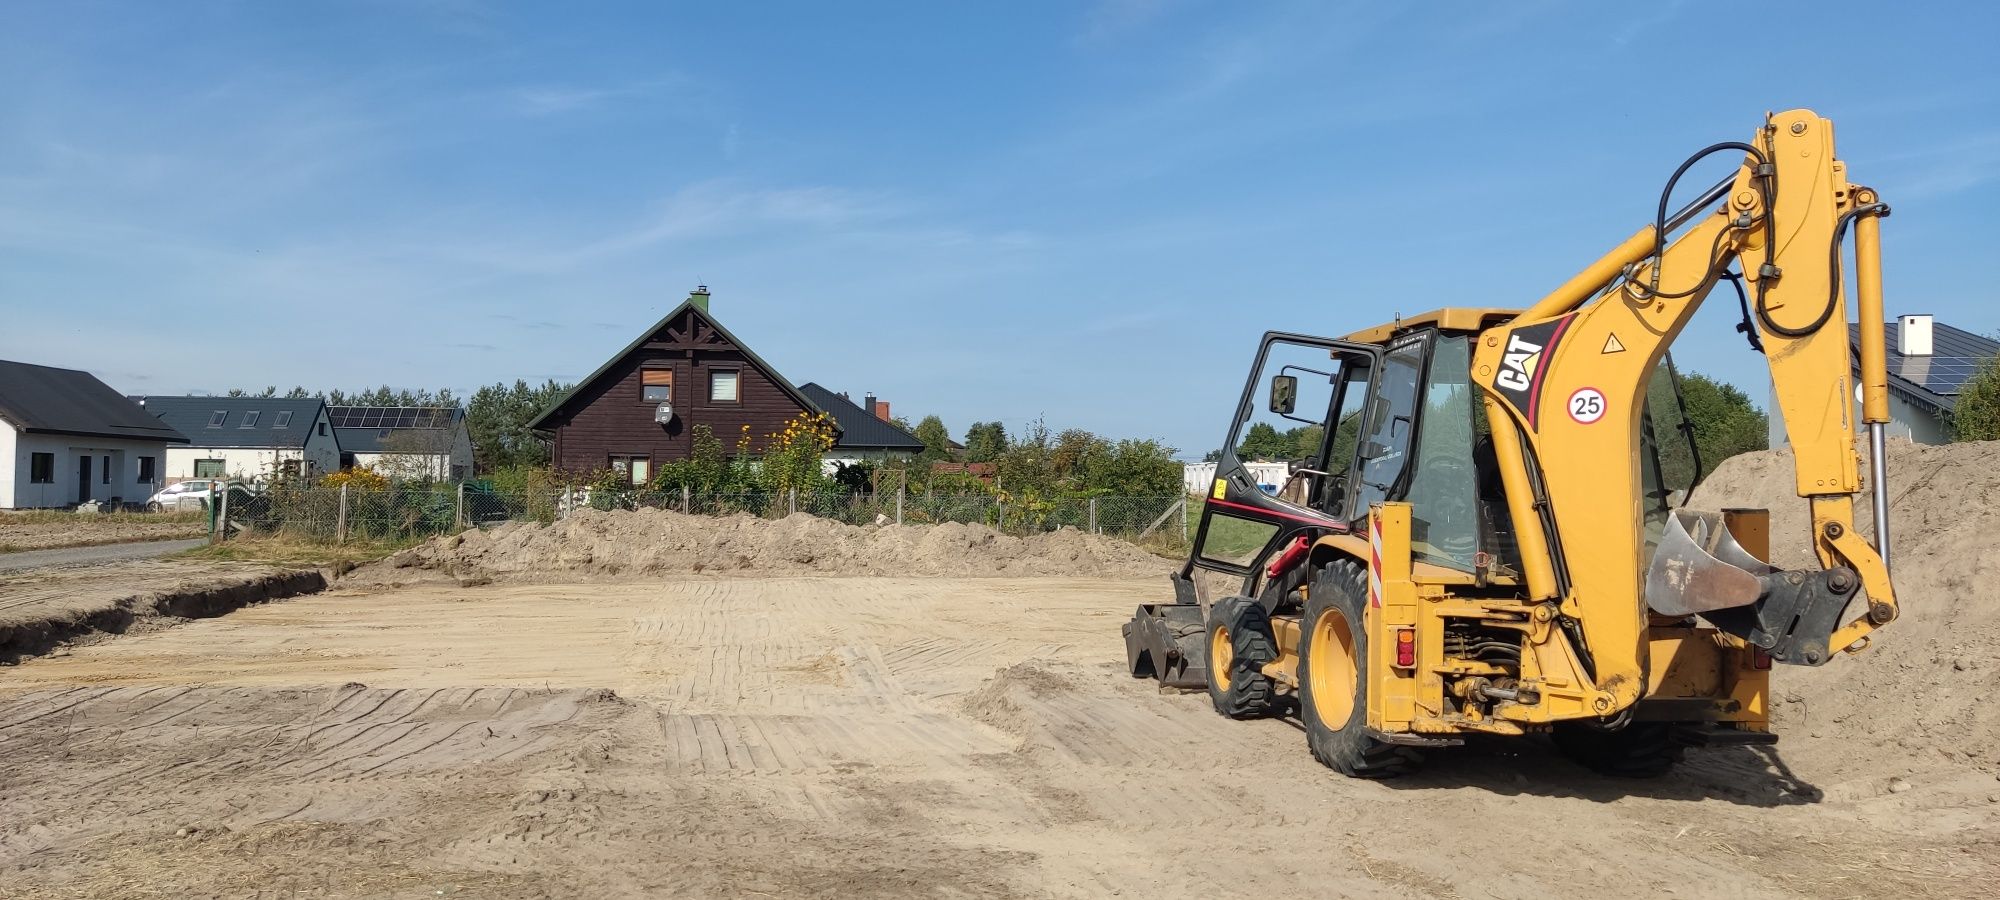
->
[0,360,188,444]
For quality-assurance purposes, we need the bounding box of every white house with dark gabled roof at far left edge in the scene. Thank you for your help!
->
[0,360,188,510]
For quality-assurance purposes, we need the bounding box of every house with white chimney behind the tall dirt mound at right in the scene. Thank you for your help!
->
[1770,316,2000,446]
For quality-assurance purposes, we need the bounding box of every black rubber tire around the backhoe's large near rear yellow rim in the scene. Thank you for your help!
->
[1298,558,1424,778]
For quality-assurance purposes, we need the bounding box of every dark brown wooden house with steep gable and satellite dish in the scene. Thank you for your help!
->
[530,288,820,484]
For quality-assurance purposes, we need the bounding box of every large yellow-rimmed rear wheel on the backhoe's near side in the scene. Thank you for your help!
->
[1298,560,1422,778]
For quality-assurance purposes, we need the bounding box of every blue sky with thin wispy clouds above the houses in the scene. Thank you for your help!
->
[0,0,2000,456]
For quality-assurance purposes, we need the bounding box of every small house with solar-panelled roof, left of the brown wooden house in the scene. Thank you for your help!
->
[338,406,472,482]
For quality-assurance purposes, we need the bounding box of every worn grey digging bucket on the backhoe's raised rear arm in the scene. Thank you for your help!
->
[1646,510,1860,666]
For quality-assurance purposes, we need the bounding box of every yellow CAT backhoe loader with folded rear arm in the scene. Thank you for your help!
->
[1124,110,1896,778]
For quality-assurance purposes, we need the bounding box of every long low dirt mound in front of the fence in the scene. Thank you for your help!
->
[354,510,1170,582]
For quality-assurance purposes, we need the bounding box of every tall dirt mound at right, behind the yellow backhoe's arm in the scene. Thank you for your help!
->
[1690,442,2000,766]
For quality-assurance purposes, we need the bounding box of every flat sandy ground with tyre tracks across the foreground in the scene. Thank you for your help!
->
[0,578,2000,898]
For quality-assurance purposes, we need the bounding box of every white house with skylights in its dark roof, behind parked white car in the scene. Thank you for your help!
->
[138,396,340,484]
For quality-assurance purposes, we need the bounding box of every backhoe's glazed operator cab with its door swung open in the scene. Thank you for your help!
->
[1182,324,1698,596]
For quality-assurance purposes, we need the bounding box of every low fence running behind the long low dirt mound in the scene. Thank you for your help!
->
[214,486,1188,548]
